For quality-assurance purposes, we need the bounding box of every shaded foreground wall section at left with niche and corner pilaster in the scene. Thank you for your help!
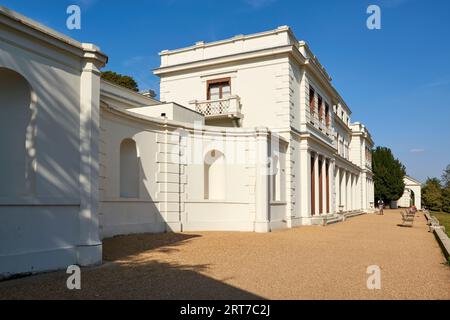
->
[0,9,106,277]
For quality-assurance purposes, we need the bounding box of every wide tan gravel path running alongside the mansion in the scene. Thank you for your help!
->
[0,210,450,300]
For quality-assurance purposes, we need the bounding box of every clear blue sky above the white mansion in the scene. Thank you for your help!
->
[0,0,450,181]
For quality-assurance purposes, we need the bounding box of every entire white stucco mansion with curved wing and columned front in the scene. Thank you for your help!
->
[0,7,374,277]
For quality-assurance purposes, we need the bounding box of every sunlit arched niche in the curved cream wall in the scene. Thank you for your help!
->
[204,150,226,200]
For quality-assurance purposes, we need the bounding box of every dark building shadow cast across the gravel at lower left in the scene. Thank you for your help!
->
[0,234,263,300]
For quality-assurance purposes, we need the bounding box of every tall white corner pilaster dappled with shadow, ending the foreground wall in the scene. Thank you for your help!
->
[77,44,106,266]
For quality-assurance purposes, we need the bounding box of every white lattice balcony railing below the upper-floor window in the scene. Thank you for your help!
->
[190,96,242,118]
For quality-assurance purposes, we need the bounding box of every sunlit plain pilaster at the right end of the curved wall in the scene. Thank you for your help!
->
[255,128,270,232]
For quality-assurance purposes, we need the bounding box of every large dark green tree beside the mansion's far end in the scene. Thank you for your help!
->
[372,147,406,203]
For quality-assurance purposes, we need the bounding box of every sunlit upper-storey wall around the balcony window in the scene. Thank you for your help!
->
[160,56,290,128]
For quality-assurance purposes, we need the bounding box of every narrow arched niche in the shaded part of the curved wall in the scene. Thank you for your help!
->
[120,139,139,198]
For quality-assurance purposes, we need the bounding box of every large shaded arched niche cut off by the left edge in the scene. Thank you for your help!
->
[0,68,35,197]
